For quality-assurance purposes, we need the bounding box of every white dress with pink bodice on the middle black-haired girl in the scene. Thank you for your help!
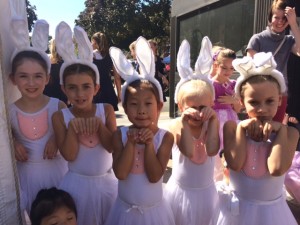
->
[106,127,175,225]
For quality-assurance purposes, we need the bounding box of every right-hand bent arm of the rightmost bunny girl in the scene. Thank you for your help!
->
[264,121,299,176]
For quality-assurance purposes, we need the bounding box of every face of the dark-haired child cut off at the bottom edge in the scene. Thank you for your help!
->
[41,206,77,225]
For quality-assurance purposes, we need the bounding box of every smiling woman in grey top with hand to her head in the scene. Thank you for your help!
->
[246,0,300,122]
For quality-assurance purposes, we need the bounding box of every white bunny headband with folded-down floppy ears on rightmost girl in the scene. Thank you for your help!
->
[232,52,286,97]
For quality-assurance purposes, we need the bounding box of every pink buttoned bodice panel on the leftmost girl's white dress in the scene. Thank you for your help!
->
[17,109,49,140]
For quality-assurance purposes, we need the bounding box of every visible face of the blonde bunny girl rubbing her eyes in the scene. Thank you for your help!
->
[178,90,213,127]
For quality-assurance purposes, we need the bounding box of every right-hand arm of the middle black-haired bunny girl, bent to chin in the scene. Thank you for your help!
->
[140,129,174,183]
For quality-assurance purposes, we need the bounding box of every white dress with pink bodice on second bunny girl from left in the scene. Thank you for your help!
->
[60,104,117,225]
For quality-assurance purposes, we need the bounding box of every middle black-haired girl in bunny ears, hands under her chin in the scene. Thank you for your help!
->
[106,37,174,225]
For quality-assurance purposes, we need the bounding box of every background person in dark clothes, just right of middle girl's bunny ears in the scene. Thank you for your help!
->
[148,39,168,102]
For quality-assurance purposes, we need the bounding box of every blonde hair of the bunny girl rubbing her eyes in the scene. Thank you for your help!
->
[177,80,213,105]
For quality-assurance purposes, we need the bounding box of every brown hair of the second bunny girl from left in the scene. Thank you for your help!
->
[63,63,96,86]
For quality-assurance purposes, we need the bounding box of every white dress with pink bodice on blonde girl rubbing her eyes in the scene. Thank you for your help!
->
[165,124,219,225]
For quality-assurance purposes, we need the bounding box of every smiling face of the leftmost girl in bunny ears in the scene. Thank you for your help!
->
[11,59,50,99]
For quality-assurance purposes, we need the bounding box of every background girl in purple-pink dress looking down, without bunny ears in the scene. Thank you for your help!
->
[211,48,241,181]
